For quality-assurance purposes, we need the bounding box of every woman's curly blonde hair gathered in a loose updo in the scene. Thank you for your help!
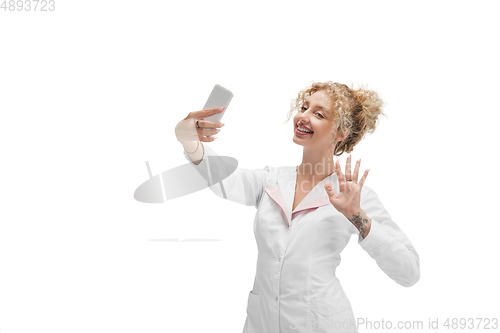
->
[285,81,386,156]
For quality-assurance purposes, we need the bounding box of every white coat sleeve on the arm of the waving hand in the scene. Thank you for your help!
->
[358,186,420,287]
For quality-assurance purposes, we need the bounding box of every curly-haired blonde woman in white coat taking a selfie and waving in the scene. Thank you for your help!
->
[176,82,420,333]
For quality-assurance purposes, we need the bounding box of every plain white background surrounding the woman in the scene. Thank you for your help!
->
[0,0,500,333]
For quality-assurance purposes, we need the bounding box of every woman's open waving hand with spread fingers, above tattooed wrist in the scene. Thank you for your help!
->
[325,155,370,219]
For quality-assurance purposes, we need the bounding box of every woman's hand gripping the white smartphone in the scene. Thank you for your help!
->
[175,108,224,143]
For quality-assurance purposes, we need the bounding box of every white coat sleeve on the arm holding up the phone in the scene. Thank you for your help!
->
[184,145,275,207]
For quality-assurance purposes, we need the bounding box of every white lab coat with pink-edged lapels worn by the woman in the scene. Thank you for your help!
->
[184,145,420,333]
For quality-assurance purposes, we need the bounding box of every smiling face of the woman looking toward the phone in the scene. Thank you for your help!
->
[293,90,340,147]
